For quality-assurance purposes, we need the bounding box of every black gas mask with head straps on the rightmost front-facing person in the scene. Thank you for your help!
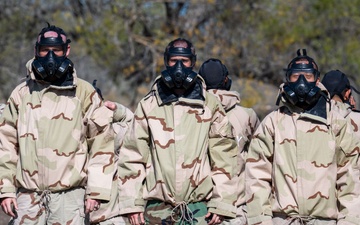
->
[283,49,321,106]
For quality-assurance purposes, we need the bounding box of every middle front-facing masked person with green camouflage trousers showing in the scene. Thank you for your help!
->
[119,38,237,225]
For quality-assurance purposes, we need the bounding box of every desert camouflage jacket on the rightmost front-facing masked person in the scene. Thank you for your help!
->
[246,84,360,224]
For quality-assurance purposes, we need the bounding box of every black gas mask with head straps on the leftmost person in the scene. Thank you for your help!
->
[32,24,73,82]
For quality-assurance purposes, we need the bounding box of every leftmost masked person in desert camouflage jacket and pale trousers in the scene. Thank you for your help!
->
[0,25,114,225]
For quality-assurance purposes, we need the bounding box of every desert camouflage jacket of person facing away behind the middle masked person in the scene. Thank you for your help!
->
[208,89,260,209]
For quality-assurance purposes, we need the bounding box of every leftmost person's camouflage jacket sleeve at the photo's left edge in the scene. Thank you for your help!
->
[0,95,19,198]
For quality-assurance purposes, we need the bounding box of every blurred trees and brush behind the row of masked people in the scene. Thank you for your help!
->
[0,0,360,118]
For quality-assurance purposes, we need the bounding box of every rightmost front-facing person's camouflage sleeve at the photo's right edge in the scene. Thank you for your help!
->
[333,115,360,224]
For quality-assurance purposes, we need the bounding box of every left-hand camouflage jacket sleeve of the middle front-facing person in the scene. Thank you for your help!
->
[118,103,150,215]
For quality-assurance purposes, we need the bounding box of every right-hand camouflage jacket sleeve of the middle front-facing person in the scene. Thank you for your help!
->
[208,101,238,217]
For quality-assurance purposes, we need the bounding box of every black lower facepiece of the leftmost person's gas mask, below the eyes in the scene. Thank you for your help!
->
[32,50,73,82]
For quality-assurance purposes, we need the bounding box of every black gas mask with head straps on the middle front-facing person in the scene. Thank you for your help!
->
[161,38,197,89]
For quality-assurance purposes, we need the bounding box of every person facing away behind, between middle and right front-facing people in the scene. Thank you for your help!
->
[199,58,260,225]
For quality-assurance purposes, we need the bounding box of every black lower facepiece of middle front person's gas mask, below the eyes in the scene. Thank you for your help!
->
[161,60,197,89]
